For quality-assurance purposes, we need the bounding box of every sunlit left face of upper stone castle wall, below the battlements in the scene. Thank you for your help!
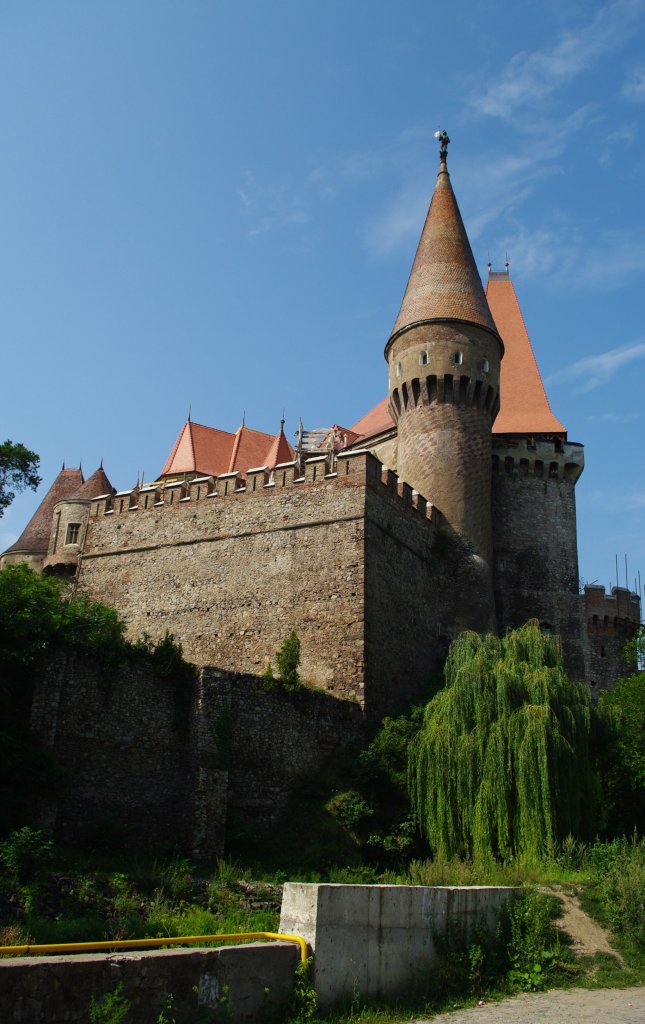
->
[79,456,370,702]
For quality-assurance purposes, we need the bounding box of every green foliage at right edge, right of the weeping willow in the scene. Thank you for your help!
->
[596,671,645,835]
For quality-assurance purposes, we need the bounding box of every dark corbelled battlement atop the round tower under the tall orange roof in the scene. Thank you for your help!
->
[492,437,585,483]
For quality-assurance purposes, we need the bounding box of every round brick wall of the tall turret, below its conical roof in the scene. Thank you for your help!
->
[388,323,501,630]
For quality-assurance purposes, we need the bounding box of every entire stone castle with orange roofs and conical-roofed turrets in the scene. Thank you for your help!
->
[2,133,640,718]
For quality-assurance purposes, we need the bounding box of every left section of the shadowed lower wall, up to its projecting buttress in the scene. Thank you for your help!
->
[31,651,226,855]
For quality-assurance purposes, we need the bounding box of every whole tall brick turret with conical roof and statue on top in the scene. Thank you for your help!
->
[385,132,504,628]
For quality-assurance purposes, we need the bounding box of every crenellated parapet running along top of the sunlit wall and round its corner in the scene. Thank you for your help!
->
[90,450,440,524]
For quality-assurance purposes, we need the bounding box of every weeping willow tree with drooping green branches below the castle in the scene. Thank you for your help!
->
[409,622,597,860]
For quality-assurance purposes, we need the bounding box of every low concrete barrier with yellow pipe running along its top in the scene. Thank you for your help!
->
[0,942,298,1024]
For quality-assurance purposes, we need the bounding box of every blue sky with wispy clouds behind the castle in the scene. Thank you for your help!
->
[0,0,645,598]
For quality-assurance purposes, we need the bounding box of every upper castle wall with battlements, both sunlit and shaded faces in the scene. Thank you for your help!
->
[78,453,446,714]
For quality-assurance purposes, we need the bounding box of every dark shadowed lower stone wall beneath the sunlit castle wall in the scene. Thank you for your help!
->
[31,650,364,860]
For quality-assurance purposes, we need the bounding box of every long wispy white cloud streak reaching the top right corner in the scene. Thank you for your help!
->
[470,0,644,119]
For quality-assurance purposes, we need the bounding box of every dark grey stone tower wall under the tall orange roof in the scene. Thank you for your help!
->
[492,440,585,679]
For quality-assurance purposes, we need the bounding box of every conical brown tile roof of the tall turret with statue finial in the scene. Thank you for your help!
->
[388,151,497,344]
